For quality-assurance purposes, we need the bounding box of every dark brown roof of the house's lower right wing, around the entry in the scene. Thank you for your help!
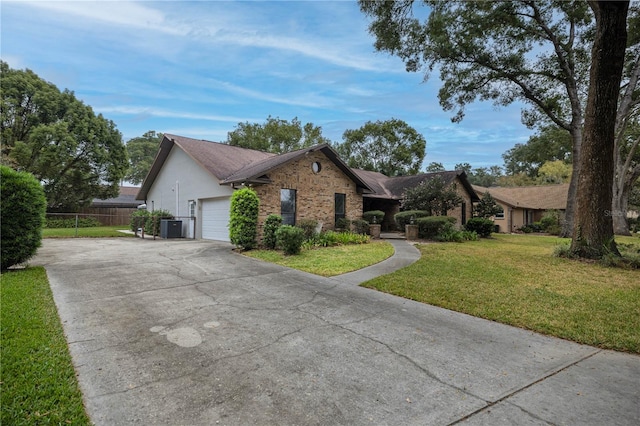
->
[353,169,480,202]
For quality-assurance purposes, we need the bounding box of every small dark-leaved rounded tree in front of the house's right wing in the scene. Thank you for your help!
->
[401,177,462,216]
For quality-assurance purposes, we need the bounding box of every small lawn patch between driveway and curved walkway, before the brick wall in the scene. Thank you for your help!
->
[244,241,394,277]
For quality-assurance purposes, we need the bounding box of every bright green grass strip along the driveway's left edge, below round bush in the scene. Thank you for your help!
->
[0,267,90,425]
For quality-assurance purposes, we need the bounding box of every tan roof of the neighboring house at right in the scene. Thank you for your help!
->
[473,183,569,210]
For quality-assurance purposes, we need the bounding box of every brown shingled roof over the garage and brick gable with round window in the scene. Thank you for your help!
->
[136,134,372,200]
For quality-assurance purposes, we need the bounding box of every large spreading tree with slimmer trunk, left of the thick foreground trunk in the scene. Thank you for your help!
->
[360,0,593,233]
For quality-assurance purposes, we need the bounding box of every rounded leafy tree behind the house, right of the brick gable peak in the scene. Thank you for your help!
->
[335,118,427,176]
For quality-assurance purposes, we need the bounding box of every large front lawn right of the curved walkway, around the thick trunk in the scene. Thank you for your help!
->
[362,235,640,353]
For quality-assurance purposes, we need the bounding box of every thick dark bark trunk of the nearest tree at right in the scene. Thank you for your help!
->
[571,1,629,259]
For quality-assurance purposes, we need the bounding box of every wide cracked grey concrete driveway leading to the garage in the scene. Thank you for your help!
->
[32,238,640,425]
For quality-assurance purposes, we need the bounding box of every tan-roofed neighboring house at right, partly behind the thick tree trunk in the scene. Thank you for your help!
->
[473,183,569,233]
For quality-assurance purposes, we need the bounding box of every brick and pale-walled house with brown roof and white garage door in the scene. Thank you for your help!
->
[136,134,477,241]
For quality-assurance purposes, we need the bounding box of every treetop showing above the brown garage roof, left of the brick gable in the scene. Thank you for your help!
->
[227,116,331,154]
